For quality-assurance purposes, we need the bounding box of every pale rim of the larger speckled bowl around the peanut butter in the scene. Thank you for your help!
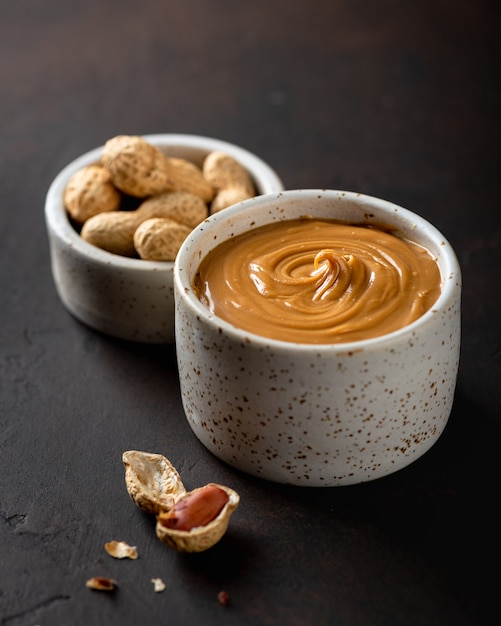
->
[174,189,462,354]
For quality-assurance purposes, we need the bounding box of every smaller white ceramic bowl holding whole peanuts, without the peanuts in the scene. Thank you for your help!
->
[45,134,283,343]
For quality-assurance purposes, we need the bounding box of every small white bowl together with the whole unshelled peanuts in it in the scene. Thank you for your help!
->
[45,134,283,344]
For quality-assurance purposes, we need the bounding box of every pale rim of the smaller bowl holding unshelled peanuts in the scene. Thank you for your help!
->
[45,133,284,273]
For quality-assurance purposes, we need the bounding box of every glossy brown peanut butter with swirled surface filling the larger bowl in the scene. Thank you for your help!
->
[194,218,441,344]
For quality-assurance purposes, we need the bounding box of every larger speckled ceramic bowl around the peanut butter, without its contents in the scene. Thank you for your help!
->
[174,190,461,486]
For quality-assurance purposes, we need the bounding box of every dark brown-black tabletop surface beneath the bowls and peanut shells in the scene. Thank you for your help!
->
[0,0,501,626]
